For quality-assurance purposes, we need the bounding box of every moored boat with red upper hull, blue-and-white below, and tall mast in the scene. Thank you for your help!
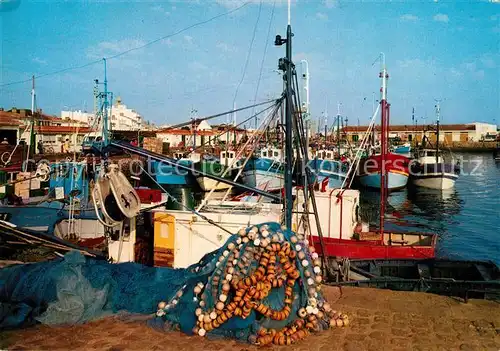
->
[358,66,410,191]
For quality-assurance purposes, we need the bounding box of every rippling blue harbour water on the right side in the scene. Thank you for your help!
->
[361,153,500,264]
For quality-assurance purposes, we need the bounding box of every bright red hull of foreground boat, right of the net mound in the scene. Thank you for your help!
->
[313,236,436,259]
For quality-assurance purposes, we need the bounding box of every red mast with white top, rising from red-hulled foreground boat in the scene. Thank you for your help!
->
[379,53,389,240]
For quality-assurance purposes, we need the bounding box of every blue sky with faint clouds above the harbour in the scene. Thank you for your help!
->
[0,0,500,127]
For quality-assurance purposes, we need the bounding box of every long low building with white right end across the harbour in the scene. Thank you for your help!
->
[343,122,497,143]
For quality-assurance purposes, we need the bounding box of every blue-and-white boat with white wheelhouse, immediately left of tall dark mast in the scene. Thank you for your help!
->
[243,147,285,191]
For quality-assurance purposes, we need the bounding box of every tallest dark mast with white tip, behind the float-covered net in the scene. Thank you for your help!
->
[274,0,293,229]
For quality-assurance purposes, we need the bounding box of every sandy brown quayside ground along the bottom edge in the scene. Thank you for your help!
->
[0,288,500,351]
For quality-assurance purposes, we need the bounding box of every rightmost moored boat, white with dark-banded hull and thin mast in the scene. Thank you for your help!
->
[410,103,460,189]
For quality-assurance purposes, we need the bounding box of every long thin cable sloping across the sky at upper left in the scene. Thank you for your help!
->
[0,1,251,88]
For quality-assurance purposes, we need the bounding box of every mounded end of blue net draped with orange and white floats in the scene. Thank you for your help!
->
[150,223,349,345]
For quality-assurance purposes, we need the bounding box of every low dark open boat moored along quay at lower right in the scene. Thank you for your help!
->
[339,259,500,300]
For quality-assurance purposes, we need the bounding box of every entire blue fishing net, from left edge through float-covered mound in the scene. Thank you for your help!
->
[0,223,349,345]
